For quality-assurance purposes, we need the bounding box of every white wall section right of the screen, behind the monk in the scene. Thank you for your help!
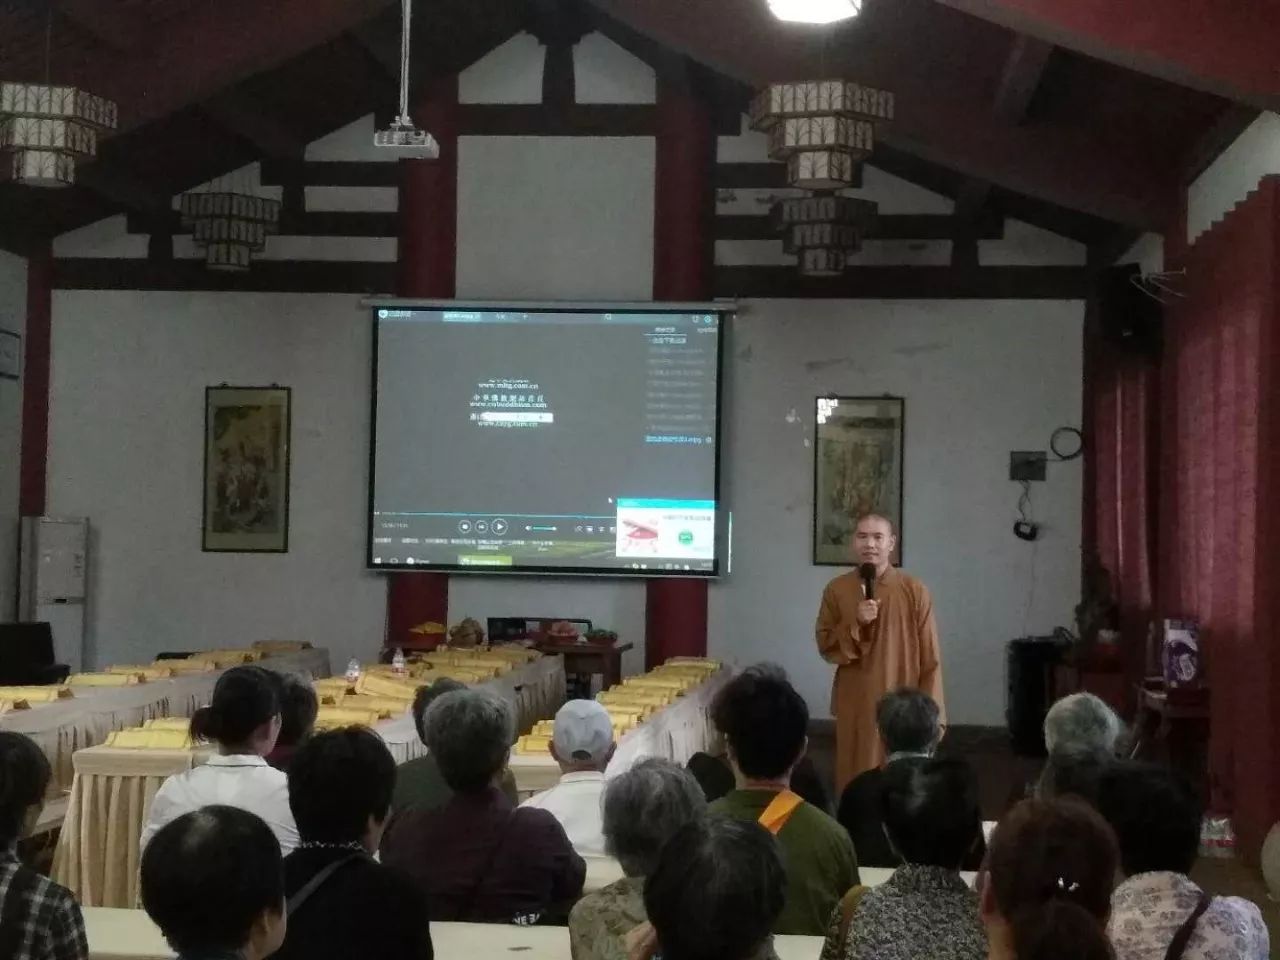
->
[710,301,1083,724]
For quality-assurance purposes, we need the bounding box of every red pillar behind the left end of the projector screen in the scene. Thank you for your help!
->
[387,77,458,646]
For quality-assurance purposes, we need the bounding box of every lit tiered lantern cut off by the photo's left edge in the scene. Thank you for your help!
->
[0,82,118,187]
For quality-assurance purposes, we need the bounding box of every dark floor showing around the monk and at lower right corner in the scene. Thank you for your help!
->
[809,727,1280,960]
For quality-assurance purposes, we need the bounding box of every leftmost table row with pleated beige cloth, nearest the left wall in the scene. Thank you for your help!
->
[0,649,329,791]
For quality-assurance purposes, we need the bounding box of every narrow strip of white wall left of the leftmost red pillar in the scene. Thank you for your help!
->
[0,251,27,621]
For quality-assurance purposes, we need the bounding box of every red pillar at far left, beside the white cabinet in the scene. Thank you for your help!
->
[18,247,54,517]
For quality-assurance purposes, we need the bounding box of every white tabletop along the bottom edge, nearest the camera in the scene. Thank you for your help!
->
[84,906,822,960]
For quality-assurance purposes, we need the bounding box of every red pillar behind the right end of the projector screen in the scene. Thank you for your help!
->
[645,79,716,667]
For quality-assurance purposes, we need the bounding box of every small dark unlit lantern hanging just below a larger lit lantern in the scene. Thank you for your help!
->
[769,193,878,276]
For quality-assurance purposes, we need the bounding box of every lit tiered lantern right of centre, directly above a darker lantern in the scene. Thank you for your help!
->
[751,81,893,189]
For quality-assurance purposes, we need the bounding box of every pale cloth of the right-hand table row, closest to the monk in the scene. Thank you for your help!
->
[511,667,733,797]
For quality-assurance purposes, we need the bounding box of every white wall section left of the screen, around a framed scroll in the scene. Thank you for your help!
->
[49,292,387,666]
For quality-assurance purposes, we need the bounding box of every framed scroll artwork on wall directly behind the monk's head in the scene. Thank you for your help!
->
[813,397,906,567]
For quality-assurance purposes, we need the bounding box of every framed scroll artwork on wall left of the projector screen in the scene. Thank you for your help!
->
[204,387,291,553]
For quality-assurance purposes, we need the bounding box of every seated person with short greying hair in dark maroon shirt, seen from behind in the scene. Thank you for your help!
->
[383,690,586,924]
